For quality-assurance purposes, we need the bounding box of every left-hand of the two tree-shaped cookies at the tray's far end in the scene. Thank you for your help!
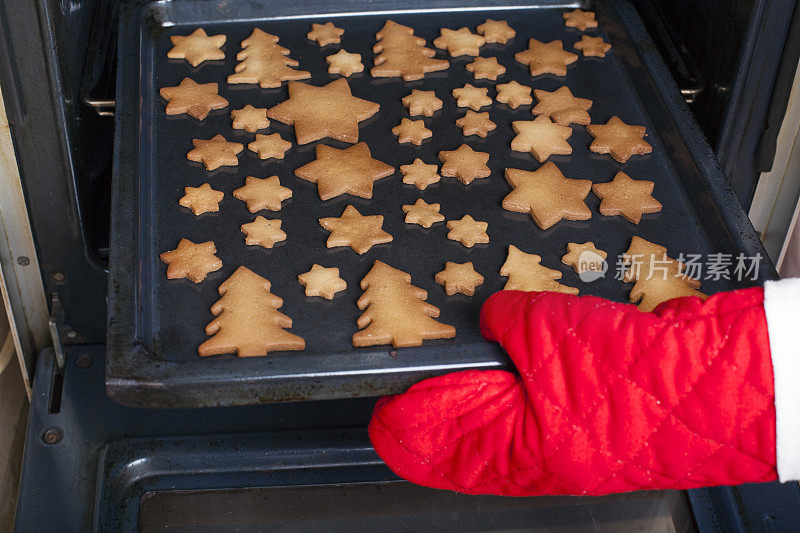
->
[228,28,311,89]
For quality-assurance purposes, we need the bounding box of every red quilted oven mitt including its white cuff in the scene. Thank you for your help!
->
[369,280,800,496]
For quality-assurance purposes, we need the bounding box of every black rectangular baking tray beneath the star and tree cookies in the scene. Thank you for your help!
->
[106,0,775,407]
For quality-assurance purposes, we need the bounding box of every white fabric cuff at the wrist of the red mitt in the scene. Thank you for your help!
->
[764,278,800,481]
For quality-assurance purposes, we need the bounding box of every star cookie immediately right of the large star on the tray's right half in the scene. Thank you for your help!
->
[592,172,661,224]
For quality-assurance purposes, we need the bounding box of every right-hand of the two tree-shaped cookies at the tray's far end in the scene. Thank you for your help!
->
[370,20,450,81]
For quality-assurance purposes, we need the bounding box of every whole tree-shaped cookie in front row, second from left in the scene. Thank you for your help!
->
[353,261,456,347]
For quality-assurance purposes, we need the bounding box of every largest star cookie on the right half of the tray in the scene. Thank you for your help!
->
[502,161,592,229]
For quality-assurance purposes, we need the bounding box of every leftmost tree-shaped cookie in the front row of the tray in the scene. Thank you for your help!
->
[197,267,306,357]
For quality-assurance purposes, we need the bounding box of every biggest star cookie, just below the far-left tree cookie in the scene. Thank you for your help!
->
[267,78,380,144]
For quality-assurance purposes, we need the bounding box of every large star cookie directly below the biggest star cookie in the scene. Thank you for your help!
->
[294,142,394,200]
